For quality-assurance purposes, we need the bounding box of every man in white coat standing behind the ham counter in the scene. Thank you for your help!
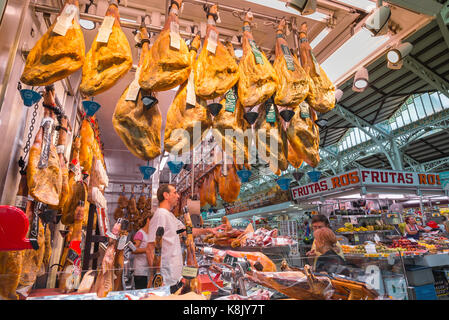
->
[146,184,218,292]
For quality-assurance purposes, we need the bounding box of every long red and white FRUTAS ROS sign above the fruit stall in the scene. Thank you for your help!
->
[291,169,441,200]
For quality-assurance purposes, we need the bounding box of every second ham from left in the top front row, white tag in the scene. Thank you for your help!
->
[80,0,133,96]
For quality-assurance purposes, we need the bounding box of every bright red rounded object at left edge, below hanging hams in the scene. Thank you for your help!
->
[0,206,32,251]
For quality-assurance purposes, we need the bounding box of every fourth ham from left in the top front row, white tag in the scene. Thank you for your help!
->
[193,5,239,100]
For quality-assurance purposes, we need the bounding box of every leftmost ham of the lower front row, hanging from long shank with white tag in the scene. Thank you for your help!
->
[112,19,162,160]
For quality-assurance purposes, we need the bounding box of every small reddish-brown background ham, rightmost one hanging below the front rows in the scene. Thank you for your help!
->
[214,164,241,203]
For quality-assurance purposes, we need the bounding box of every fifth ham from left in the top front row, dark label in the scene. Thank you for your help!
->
[238,12,278,108]
